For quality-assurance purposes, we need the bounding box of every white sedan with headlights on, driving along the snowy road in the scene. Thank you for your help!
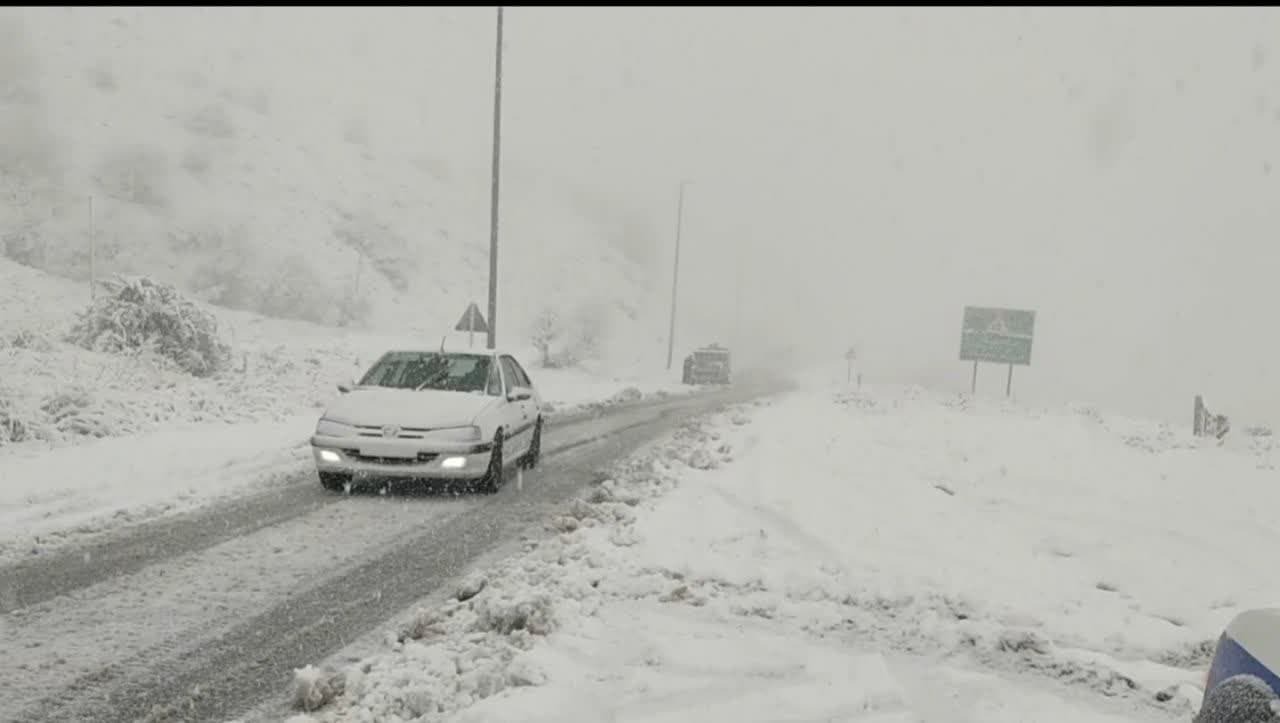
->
[311,349,543,493]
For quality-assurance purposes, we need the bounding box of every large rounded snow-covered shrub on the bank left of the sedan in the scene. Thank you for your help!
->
[69,276,230,376]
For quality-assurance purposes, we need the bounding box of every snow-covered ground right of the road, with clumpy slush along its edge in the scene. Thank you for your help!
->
[257,378,1280,723]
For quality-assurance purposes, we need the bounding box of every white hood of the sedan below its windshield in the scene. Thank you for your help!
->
[324,388,497,427]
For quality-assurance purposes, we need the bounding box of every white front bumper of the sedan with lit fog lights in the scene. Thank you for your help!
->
[311,435,493,480]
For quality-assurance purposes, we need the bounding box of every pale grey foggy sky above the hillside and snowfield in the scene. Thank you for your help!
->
[17,8,1280,422]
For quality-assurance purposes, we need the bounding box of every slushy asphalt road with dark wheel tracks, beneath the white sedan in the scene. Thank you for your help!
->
[0,383,778,723]
